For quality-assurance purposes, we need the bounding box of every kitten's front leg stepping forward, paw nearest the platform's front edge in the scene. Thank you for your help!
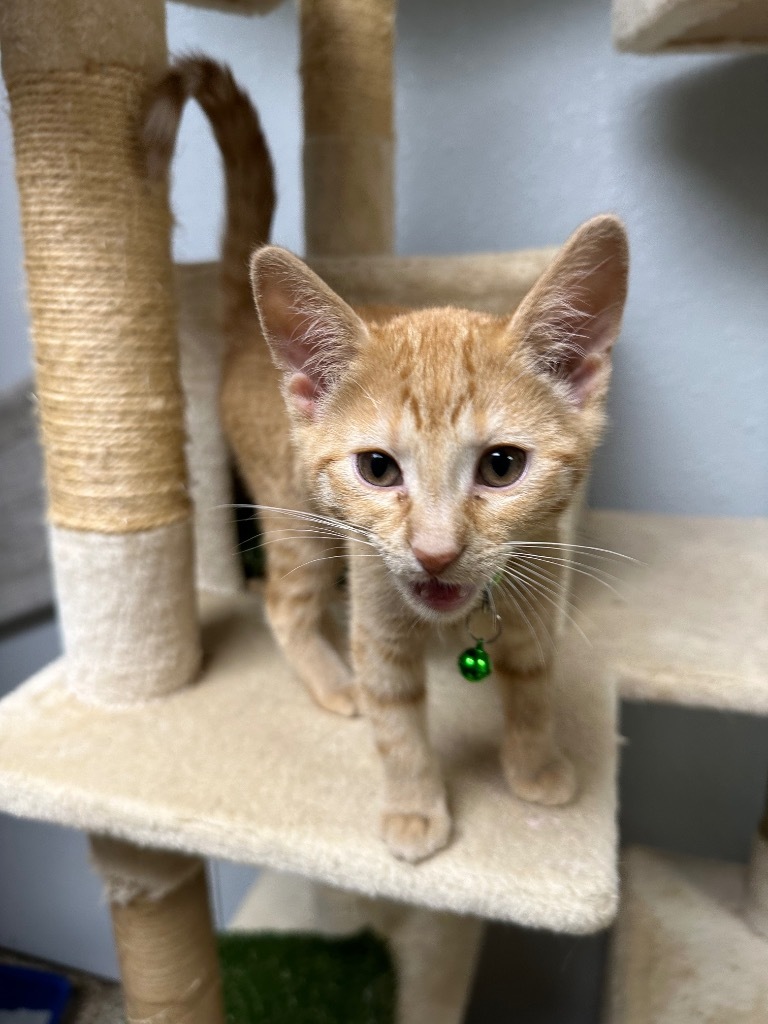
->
[350,560,451,863]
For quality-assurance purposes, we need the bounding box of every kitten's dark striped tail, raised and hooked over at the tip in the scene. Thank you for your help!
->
[141,54,275,333]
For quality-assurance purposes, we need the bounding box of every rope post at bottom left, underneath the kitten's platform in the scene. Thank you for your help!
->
[91,837,224,1024]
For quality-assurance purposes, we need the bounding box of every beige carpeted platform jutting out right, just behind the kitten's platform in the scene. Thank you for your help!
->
[575,511,768,714]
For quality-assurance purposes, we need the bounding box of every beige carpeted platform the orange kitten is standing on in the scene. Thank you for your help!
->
[0,598,616,932]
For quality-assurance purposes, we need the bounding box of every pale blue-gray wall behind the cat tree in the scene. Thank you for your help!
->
[0,0,768,1007]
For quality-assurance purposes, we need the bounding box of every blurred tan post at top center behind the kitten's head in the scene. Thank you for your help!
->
[301,0,394,256]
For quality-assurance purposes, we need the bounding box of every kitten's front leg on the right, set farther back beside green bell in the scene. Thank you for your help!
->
[494,631,577,806]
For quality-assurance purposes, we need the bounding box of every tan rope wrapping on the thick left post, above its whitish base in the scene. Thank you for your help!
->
[7,67,189,534]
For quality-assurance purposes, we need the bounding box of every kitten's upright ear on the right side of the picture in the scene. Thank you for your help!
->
[511,214,629,407]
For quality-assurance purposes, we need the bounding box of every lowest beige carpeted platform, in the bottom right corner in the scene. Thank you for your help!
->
[603,849,768,1024]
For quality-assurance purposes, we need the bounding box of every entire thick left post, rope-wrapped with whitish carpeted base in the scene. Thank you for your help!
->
[0,0,200,703]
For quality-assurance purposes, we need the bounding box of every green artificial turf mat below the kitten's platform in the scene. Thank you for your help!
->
[218,932,395,1024]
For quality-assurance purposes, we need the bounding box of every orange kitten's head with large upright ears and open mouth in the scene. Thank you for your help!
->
[249,218,626,621]
